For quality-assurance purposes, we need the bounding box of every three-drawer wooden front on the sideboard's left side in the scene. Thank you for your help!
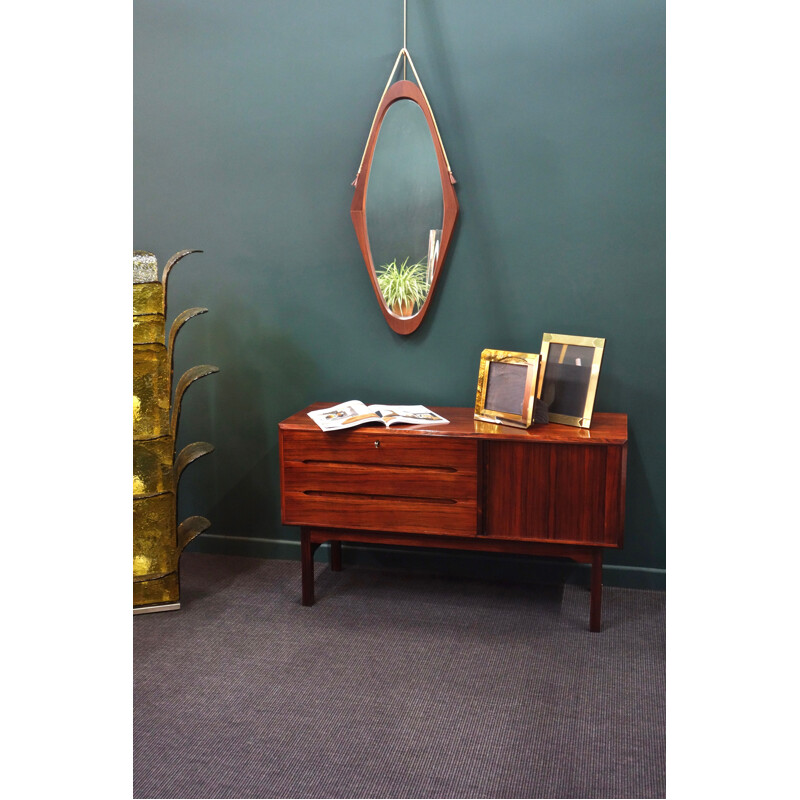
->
[281,430,478,536]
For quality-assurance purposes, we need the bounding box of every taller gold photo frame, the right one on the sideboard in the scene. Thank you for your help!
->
[536,333,606,428]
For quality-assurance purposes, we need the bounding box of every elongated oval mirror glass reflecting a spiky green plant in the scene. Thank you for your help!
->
[365,98,444,318]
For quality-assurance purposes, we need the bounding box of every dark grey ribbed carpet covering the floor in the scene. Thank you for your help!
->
[133,551,665,798]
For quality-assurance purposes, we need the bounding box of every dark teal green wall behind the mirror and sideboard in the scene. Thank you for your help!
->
[133,0,665,585]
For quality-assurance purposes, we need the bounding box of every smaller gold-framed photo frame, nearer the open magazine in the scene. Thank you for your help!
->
[475,350,540,428]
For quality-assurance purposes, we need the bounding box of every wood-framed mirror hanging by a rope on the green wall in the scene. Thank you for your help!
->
[350,25,458,334]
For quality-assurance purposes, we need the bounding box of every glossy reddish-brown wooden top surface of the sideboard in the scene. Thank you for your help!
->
[278,402,628,445]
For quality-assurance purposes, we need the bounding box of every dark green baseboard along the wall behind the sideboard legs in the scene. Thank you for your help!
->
[187,533,666,591]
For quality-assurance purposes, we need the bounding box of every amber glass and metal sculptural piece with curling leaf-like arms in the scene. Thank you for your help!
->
[133,250,219,614]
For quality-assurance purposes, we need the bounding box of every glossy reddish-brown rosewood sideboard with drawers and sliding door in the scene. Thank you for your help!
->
[279,403,628,631]
